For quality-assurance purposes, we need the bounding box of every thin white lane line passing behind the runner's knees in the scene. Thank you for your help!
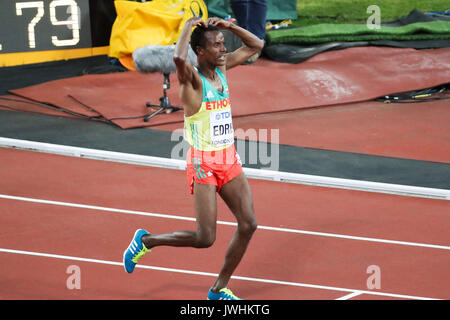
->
[0,194,450,250]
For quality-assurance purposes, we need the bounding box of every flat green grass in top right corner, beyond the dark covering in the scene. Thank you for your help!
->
[292,0,450,26]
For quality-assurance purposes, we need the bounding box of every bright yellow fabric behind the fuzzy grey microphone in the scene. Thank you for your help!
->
[109,0,208,58]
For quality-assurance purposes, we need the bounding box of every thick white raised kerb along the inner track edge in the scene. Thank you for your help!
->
[0,137,450,200]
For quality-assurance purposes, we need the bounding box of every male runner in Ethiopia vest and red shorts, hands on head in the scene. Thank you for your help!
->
[123,17,264,300]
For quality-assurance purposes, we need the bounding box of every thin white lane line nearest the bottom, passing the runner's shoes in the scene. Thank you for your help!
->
[0,248,440,300]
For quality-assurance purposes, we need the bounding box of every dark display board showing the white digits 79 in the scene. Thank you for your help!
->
[0,0,116,54]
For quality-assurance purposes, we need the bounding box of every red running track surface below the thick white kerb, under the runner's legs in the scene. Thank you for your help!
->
[0,149,450,299]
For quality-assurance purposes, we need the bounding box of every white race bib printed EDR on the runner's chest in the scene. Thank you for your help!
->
[209,110,234,147]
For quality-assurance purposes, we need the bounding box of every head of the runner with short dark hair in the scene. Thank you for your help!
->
[191,25,227,66]
